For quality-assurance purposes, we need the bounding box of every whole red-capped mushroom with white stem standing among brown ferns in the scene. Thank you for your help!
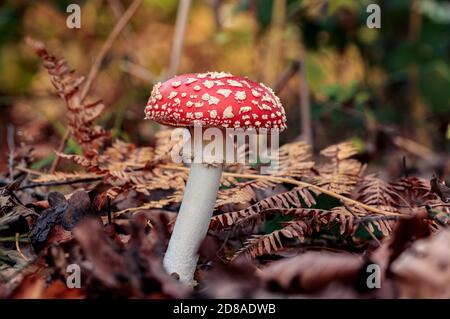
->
[145,72,286,283]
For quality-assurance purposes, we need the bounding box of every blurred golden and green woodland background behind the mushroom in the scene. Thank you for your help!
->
[0,0,450,177]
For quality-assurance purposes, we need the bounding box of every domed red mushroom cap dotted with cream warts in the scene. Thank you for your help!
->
[145,72,286,132]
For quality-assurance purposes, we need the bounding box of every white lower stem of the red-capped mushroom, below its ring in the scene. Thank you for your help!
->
[164,163,222,284]
